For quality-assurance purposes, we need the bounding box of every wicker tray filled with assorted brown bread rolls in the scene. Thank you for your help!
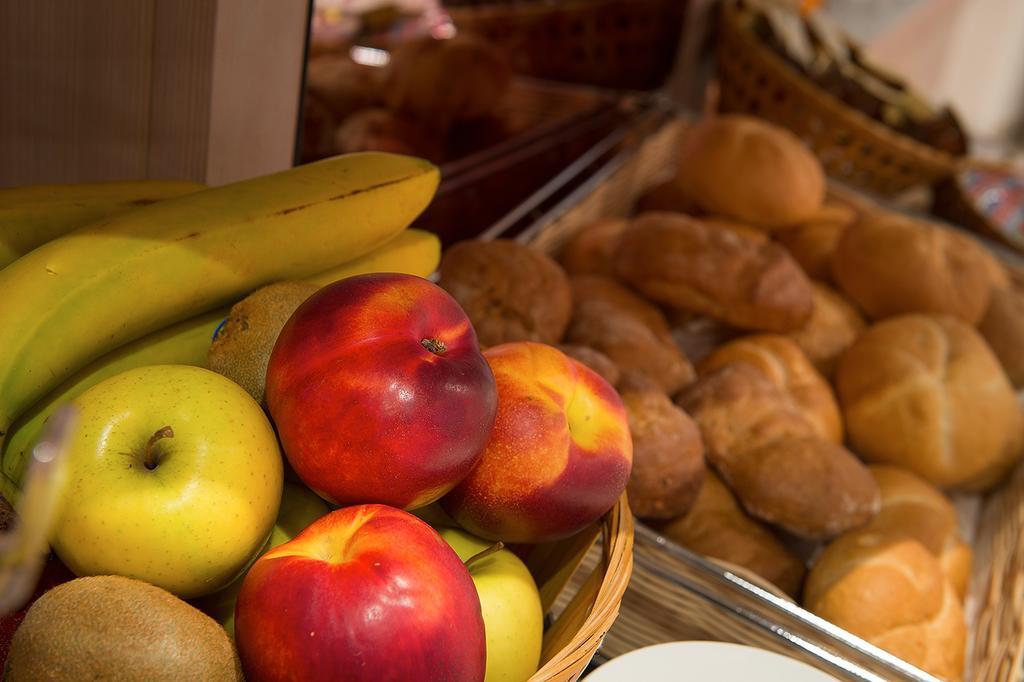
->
[460,115,1024,681]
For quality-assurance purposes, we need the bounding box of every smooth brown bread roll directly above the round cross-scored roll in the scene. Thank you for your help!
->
[831,212,992,325]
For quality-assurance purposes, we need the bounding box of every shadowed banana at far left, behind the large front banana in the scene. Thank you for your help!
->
[0,180,206,268]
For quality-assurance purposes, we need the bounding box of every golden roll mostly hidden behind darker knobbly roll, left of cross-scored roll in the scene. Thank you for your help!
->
[700,334,843,442]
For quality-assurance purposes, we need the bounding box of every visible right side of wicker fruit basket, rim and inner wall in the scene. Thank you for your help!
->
[524,494,633,682]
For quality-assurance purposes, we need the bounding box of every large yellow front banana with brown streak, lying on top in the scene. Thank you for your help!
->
[0,152,438,446]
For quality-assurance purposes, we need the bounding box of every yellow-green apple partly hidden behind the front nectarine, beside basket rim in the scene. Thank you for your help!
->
[438,528,544,682]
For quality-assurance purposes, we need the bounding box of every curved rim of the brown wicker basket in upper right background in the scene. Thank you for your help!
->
[719,0,966,173]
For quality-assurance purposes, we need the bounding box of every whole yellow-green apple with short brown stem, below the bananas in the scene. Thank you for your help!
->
[53,365,282,598]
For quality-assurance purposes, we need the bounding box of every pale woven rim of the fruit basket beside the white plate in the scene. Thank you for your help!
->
[529,493,633,682]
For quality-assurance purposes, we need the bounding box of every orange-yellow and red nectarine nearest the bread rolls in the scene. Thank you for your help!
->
[441,342,633,543]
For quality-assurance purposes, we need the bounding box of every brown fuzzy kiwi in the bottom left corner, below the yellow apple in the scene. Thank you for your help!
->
[4,576,243,682]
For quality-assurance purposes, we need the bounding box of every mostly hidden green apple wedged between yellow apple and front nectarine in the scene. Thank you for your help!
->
[196,480,331,637]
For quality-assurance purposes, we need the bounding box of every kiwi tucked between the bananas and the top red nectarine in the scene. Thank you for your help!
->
[206,282,319,404]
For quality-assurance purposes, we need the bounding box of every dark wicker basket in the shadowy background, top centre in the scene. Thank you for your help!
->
[446,0,686,90]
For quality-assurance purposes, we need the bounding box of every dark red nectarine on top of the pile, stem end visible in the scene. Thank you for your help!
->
[266,273,498,509]
